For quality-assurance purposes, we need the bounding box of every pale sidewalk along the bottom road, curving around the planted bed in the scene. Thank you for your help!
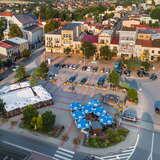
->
[0,120,138,156]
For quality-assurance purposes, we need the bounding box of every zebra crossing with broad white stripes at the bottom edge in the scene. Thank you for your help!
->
[53,147,75,160]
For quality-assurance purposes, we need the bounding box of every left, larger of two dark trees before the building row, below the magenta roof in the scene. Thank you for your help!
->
[81,42,96,59]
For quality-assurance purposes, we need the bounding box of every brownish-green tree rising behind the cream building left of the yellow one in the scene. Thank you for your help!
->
[44,20,60,33]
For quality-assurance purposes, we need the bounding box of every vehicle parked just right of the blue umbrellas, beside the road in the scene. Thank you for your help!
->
[121,108,138,122]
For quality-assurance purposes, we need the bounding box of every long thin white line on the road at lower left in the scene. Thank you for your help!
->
[2,141,53,158]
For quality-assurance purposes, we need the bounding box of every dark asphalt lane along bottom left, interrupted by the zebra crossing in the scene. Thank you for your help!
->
[0,129,91,160]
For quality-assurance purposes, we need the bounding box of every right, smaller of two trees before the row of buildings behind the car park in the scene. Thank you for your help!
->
[100,46,113,60]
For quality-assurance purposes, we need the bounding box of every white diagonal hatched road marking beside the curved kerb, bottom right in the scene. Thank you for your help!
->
[100,146,135,160]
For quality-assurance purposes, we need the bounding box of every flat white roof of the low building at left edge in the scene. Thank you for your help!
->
[0,83,52,112]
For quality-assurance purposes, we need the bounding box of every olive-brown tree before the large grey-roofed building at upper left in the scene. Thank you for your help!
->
[9,24,23,38]
